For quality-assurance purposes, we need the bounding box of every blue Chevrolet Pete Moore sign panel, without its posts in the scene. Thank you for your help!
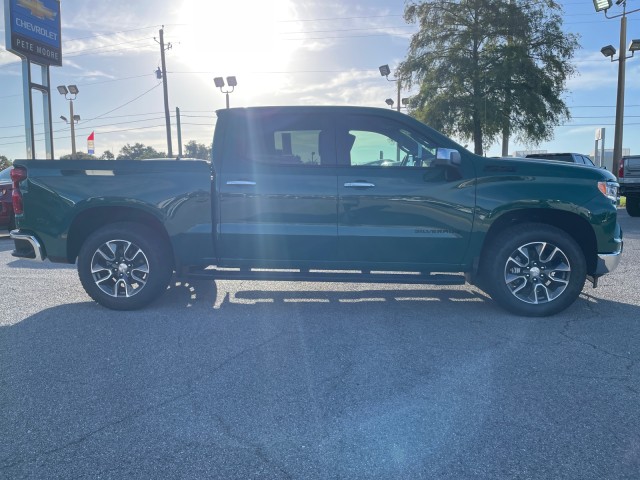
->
[5,0,62,66]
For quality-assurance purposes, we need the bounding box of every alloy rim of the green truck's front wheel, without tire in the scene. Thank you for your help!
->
[504,242,571,304]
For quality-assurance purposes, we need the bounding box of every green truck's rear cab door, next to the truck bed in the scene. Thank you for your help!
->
[217,109,337,267]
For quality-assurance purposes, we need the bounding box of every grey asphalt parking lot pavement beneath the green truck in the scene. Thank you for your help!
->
[0,215,640,480]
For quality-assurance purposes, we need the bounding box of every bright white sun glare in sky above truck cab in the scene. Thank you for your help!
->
[179,0,299,76]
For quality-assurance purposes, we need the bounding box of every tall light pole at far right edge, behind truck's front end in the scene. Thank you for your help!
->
[593,0,640,176]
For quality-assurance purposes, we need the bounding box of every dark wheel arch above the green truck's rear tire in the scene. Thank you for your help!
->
[67,207,175,264]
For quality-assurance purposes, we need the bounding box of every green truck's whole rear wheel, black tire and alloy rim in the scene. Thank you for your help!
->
[78,222,173,310]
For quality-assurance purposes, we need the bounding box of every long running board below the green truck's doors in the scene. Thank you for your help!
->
[183,267,465,285]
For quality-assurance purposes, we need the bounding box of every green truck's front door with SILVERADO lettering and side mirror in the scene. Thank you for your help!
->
[336,115,474,271]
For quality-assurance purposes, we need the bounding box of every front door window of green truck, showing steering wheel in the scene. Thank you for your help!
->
[338,116,436,168]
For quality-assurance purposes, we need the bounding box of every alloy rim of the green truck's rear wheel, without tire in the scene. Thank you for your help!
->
[91,240,149,297]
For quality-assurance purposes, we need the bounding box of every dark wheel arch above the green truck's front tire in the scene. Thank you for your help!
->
[475,209,598,272]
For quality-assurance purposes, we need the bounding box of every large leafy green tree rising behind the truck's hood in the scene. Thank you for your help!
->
[398,0,577,154]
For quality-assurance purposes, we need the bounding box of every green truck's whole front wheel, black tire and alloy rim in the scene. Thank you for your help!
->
[481,223,587,317]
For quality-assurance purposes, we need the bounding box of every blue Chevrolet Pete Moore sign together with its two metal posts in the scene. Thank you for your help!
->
[4,0,62,159]
